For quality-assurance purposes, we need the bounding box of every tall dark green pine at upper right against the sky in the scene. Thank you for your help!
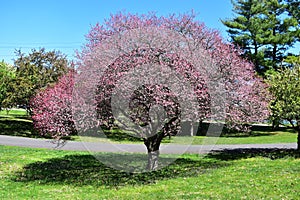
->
[222,0,299,74]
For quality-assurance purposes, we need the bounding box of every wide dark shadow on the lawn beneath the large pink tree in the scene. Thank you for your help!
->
[13,153,228,188]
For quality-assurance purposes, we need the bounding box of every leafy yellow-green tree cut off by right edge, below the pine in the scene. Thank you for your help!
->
[268,64,300,150]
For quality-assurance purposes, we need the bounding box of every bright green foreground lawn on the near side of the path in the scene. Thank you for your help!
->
[0,146,300,200]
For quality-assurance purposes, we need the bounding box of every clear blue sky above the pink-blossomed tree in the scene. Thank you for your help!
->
[0,0,233,63]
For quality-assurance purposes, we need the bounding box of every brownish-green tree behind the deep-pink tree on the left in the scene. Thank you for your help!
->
[8,48,70,111]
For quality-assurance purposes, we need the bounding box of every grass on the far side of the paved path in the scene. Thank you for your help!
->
[0,109,297,145]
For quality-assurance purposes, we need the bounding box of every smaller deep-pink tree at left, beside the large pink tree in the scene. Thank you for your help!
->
[30,71,76,139]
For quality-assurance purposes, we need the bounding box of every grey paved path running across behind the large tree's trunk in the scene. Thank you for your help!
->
[0,135,297,154]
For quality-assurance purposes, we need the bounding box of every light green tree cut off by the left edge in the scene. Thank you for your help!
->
[0,61,15,110]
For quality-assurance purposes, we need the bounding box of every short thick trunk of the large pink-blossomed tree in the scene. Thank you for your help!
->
[144,133,164,171]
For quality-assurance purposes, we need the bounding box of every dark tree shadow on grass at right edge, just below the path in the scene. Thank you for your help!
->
[206,148,300,161]
